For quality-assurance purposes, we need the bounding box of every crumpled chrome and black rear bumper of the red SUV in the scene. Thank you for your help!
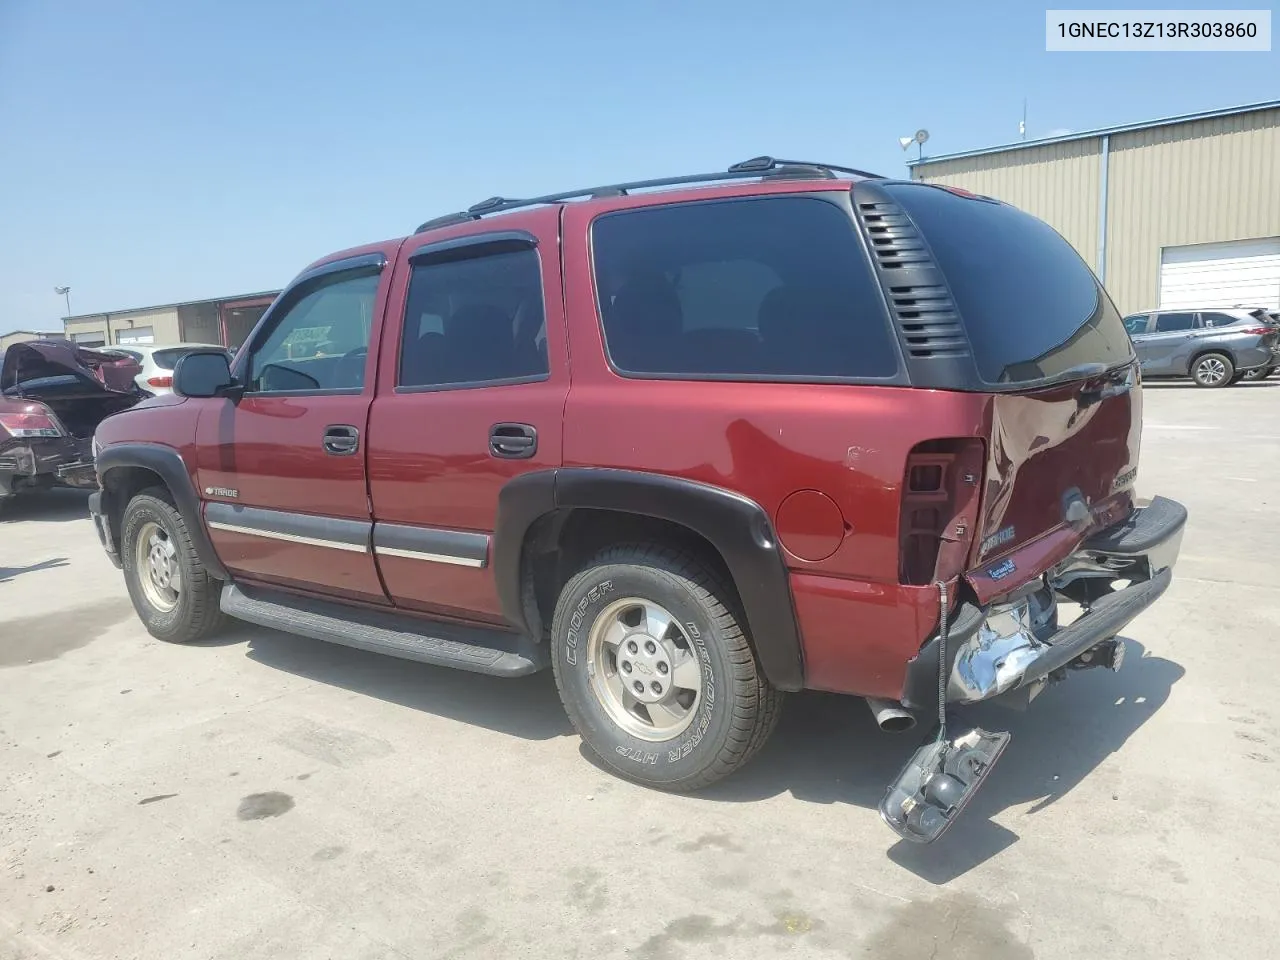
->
[902,497,1187,710]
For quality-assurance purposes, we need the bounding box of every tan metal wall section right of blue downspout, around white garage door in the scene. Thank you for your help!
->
[1107,110,1280,312]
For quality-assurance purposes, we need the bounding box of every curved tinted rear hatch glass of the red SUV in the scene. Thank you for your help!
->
[884,183,1133,384]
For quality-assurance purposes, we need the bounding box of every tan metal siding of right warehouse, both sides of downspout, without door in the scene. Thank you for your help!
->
[911,109,1280,312]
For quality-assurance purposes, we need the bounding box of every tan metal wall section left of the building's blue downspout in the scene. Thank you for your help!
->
[911,137,1102,269]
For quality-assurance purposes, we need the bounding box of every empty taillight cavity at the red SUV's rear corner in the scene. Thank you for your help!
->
[899,438,983,584]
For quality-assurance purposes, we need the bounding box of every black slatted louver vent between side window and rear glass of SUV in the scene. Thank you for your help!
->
[858,201,969,360]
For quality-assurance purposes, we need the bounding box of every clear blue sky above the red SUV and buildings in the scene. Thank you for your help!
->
[0,0,1280,330]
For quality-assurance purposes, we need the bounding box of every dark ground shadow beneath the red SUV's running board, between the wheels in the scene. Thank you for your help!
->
[240,625,573,740]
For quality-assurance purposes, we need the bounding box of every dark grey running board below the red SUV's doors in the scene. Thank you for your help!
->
[220,584,550,677]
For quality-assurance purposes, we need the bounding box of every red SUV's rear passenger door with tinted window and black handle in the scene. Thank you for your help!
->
[369,207,568,623]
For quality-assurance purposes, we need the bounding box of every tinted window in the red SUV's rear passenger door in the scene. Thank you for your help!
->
[397,244,550,389]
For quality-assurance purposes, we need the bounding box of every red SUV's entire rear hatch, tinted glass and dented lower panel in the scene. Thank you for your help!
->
[881,183,1142,586]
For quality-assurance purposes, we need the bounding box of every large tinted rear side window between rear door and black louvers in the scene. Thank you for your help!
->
[591,197,899,380]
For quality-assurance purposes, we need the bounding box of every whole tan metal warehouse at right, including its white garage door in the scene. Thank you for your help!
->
[909,100,1280,314]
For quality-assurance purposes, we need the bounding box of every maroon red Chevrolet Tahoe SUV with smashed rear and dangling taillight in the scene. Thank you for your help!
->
[92,157,1187,840]
